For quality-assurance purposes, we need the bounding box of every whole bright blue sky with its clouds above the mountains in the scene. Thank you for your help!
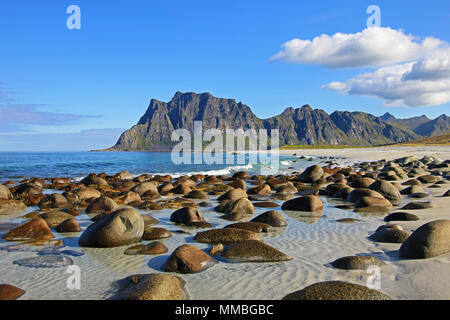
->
[0,0,450,151]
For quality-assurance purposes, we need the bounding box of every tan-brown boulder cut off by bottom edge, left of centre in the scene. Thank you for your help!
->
[111,273,188,300]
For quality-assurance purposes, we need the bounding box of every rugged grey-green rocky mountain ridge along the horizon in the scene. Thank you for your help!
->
[108,92,450,151]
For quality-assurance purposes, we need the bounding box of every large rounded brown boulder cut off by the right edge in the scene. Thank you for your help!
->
[399,220,450,259]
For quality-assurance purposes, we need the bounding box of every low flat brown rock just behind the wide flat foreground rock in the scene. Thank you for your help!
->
[194,228,262,244]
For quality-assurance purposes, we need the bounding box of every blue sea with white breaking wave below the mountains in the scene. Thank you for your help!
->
[0,152,300,182]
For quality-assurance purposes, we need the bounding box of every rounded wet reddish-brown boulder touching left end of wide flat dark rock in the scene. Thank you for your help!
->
[164,244,217,274]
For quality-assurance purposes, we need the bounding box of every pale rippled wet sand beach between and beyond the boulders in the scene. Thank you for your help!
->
[0,147,450,300]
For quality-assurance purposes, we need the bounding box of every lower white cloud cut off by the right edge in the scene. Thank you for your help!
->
[322,49,450,107]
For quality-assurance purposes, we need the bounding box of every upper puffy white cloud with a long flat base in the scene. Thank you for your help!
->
[271,28,445,68]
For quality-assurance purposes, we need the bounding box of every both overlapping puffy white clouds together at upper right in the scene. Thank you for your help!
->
[271,28,450,107]
